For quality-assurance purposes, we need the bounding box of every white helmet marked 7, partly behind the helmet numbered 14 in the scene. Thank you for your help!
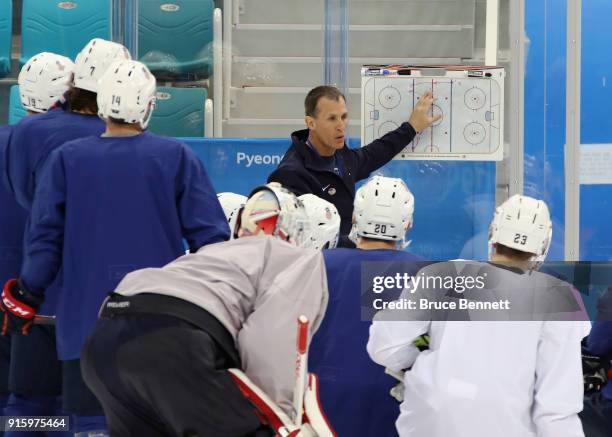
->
[74,38,132,93]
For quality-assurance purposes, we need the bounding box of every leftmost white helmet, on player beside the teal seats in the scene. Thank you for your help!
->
[17,52,74,112]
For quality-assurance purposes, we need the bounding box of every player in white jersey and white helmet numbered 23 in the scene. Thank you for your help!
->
[368,195,589,437]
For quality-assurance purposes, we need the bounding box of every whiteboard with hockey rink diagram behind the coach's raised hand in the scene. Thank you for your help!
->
[361,72,503,160]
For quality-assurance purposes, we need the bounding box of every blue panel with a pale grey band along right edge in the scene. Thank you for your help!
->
[575,0,612,316]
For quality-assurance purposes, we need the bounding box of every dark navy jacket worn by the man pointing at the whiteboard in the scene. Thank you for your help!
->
[268,123,416,243]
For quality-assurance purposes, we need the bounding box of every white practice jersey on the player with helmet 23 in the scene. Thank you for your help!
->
[368,263,590,437]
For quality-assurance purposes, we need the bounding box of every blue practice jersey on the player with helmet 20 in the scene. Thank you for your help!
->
[308,248,425,437]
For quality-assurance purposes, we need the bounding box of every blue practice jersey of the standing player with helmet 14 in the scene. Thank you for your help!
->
[21,133,229,360]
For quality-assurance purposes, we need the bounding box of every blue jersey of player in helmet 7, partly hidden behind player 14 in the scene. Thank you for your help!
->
[3,108,106,211]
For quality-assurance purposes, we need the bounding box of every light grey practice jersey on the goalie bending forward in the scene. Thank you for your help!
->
[115,236,328,413]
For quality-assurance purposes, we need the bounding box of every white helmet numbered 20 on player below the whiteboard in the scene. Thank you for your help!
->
[349,176,414,248]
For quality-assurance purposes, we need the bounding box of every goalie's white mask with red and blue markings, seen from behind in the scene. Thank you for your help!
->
[238,182,310,247]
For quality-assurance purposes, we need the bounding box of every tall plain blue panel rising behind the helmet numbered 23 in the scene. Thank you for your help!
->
[524,0,567,261]
